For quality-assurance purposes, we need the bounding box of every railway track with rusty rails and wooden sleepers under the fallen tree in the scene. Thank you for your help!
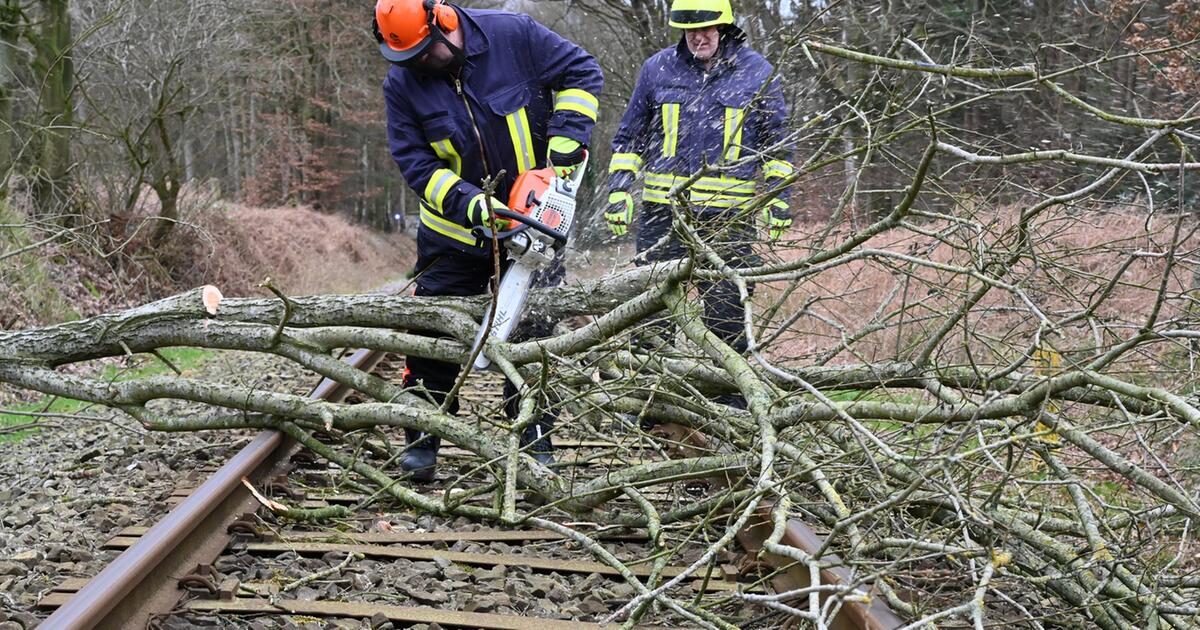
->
[38,350,902,630]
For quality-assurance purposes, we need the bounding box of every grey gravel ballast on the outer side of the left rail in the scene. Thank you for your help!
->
[0,353,314,630]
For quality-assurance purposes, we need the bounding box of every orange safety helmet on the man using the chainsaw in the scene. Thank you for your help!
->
[376,0,458,64]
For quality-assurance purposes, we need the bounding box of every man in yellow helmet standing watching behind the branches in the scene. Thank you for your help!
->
[605,0,793,398]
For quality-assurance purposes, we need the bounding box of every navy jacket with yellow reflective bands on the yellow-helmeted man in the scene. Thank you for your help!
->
[608,34,793,218]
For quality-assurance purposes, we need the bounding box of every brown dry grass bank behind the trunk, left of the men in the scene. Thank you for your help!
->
[0,190,415,329]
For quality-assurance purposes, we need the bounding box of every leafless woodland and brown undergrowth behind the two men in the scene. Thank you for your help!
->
[0,0,1200,329]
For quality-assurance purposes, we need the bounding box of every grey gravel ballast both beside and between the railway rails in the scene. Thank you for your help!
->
[0,353,768,630]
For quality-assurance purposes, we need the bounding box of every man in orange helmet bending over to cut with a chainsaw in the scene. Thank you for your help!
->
[374,0,604,481]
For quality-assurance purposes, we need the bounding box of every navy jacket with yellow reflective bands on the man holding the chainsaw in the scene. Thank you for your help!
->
[383,6,604,257]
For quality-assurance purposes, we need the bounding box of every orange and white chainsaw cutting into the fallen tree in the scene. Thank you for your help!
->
[472,152,588,371]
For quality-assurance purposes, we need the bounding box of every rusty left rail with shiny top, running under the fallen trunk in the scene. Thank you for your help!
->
[38,350,383,630]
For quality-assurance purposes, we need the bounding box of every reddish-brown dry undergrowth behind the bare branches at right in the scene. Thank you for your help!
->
[756,209,1200,374]
